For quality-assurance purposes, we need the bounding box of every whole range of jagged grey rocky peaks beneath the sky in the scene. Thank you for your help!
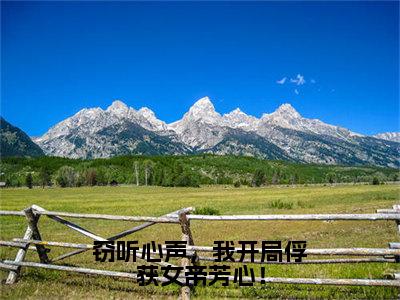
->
[27,97,400,167]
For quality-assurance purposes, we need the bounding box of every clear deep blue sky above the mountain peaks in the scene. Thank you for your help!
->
[1,1,399,135]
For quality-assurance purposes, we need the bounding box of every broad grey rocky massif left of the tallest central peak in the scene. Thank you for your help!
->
[35,100,191,158]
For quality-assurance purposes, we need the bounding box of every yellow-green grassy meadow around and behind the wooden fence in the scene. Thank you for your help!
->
[0,185,400,299]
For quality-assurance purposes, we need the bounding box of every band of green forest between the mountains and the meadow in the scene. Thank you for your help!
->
[0,155,399,187]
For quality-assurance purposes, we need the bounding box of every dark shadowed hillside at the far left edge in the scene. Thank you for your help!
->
[0,117,44,157]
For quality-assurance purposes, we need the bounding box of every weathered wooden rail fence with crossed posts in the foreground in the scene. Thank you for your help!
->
[0,205,400,299]
